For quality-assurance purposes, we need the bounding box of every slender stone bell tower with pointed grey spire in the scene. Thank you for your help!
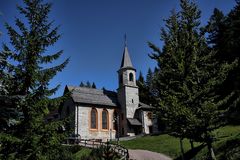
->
[118,36,139,135]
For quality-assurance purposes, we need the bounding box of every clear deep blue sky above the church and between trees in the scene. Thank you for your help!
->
[0,0,235,95]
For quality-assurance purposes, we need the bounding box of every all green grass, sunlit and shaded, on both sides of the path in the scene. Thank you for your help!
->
[71,126,240,160]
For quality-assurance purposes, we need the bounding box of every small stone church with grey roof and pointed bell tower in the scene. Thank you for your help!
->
[60,43,158,141]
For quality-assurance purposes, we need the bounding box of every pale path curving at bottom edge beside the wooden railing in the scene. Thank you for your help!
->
[128,149,171,160]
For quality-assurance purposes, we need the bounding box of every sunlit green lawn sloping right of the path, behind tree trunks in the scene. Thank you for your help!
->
[120,126,240,158]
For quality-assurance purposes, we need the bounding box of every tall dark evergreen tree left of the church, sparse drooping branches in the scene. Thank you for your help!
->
[0,0,70,159]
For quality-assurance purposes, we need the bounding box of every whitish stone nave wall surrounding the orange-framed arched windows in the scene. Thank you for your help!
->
[75,106,116,141]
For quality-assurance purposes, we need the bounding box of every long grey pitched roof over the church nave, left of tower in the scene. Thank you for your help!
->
[66,86,118,107]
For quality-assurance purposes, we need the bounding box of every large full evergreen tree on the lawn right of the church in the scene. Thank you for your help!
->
[149,0,236,158]
